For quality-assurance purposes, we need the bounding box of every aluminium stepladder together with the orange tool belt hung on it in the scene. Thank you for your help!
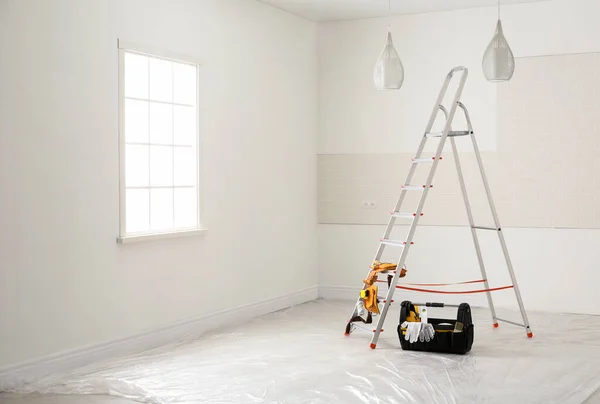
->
[345,66,533,349]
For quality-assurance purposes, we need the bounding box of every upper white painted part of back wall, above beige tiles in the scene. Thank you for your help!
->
[318,0,600,154]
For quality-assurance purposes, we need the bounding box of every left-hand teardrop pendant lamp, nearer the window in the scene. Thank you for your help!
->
[373,0,404,90]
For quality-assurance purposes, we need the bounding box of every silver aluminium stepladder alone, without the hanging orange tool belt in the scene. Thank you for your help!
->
[345,67,533,349]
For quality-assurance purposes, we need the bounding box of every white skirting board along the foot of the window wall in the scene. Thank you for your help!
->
[0,286,318,393]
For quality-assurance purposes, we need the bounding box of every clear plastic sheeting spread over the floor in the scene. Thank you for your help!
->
[4,300,600,404]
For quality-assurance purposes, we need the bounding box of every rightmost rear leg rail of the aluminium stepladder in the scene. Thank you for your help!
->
[460,103,533,337]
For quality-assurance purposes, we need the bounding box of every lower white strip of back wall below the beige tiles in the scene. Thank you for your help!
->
[319,225,600,314]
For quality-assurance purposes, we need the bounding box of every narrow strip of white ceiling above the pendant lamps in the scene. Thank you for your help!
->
[259,0,543,22]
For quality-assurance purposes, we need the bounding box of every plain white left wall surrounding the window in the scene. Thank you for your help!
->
[0,0,317,368]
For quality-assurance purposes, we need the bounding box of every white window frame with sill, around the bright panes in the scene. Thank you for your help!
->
[117,39,206,244]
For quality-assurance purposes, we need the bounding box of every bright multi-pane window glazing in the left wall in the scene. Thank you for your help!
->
[119,43,200,242]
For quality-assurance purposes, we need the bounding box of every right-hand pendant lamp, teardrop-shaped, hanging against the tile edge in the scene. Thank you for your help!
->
[481,0,515,82]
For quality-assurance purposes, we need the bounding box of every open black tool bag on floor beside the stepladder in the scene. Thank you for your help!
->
[398,301,474,354]
